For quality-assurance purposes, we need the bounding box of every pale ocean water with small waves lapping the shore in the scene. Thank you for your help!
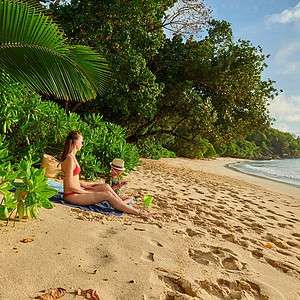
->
[229,158,300,188]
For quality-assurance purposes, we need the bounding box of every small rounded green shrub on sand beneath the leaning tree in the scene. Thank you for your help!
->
[138,137,176,159]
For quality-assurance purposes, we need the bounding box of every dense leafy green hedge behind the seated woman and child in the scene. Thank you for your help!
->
[0,78,139,179]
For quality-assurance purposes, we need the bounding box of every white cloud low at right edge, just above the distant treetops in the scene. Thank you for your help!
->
[269,93,300,123]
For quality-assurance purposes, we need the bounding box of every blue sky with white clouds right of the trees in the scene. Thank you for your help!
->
[204,0,300,136]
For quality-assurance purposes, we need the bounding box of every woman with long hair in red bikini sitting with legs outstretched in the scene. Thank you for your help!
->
[61,131,150,217]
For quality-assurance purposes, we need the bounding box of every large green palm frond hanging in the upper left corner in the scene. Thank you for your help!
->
[0,0,109,101]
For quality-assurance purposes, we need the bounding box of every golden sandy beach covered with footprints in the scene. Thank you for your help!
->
[0,158,300,300]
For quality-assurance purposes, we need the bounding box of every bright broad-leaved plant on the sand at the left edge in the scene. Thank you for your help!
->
[0,147,57,221]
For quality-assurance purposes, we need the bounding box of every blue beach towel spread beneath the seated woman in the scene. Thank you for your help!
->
[47,180,134,216]
